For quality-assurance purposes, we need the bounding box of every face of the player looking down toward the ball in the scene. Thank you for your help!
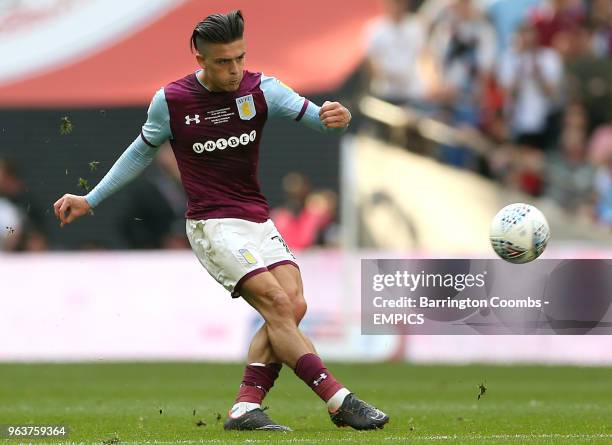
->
[196,39,246,92]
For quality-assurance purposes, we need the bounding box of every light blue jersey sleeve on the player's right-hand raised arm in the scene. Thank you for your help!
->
[261,74,344,132]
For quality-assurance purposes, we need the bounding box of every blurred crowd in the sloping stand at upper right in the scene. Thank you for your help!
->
[366,0,612,228]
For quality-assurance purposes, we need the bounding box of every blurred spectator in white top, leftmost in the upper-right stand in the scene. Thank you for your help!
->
[366,0,426,105]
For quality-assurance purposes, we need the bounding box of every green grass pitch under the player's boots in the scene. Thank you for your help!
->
[0,363,612,445]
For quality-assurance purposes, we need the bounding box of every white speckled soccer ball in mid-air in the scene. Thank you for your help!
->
[489,203,550,264]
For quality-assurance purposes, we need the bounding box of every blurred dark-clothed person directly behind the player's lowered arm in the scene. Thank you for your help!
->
[122,145,189,249]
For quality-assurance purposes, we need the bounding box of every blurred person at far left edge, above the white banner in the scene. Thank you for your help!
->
[0,158,48,251]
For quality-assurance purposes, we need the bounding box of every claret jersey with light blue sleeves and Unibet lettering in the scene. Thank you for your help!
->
[86,71,341,222]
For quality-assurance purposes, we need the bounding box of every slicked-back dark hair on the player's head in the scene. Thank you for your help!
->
[191,9,244,51]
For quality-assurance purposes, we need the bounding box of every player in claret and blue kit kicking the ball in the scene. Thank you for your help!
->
[54,11,389,431]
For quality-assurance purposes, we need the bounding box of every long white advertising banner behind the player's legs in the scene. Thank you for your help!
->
[0,251,612,364]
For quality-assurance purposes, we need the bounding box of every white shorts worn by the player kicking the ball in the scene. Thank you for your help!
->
[186,218,298,298]
